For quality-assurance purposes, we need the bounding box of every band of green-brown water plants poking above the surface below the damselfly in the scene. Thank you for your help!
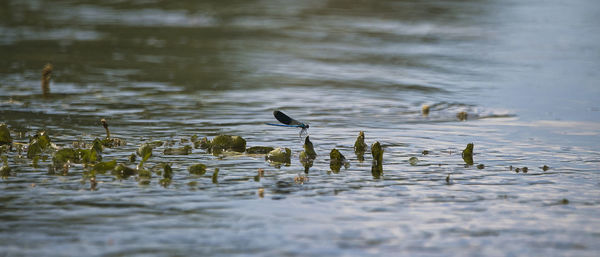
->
[0,113,549,188]
